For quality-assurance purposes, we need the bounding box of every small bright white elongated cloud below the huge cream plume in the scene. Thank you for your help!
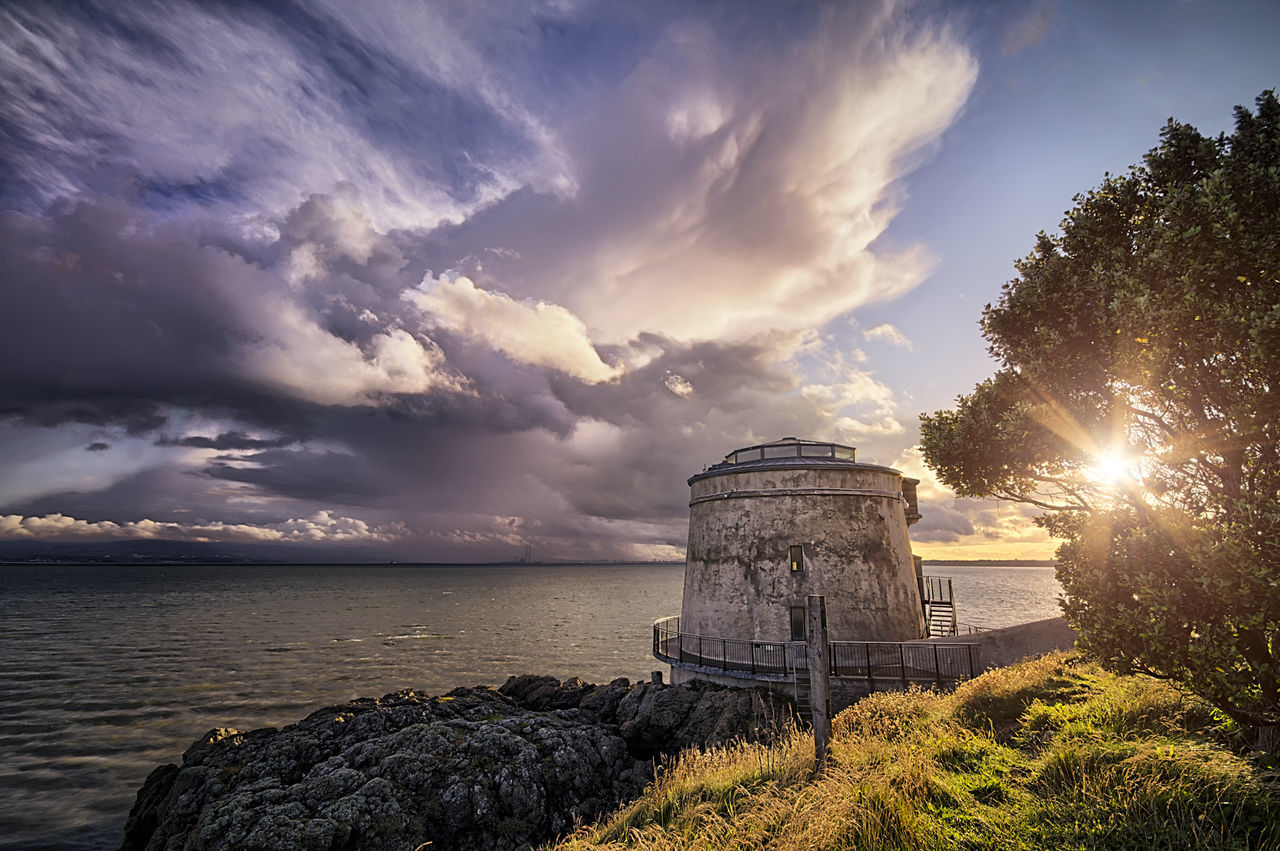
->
[404,278,620,384]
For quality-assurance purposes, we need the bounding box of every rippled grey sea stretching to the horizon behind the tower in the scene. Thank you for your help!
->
[0,564,1061,851]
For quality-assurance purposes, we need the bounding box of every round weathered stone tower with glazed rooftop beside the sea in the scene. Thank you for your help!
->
[673,438,924,650]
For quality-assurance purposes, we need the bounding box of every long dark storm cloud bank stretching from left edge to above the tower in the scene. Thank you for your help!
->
[0,184,931,557]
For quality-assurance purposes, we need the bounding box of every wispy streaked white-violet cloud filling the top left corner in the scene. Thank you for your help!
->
[0,1,559,228]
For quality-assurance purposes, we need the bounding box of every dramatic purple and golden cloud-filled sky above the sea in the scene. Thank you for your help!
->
[0,0,1280,561]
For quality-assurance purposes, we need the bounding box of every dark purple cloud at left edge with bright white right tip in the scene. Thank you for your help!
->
[0,194,466,419]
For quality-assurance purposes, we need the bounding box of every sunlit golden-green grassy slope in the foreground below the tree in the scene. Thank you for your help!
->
[554,654,1280,851]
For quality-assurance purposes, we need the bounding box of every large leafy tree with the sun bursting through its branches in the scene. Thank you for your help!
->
[920,91,1280,750]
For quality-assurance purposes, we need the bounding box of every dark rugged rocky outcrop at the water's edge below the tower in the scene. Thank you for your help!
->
[123,677,790,851]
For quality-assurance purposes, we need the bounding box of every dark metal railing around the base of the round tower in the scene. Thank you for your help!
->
[653,617,978,688]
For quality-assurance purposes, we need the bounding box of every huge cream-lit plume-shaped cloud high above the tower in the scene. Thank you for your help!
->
[424,4,977,344]
